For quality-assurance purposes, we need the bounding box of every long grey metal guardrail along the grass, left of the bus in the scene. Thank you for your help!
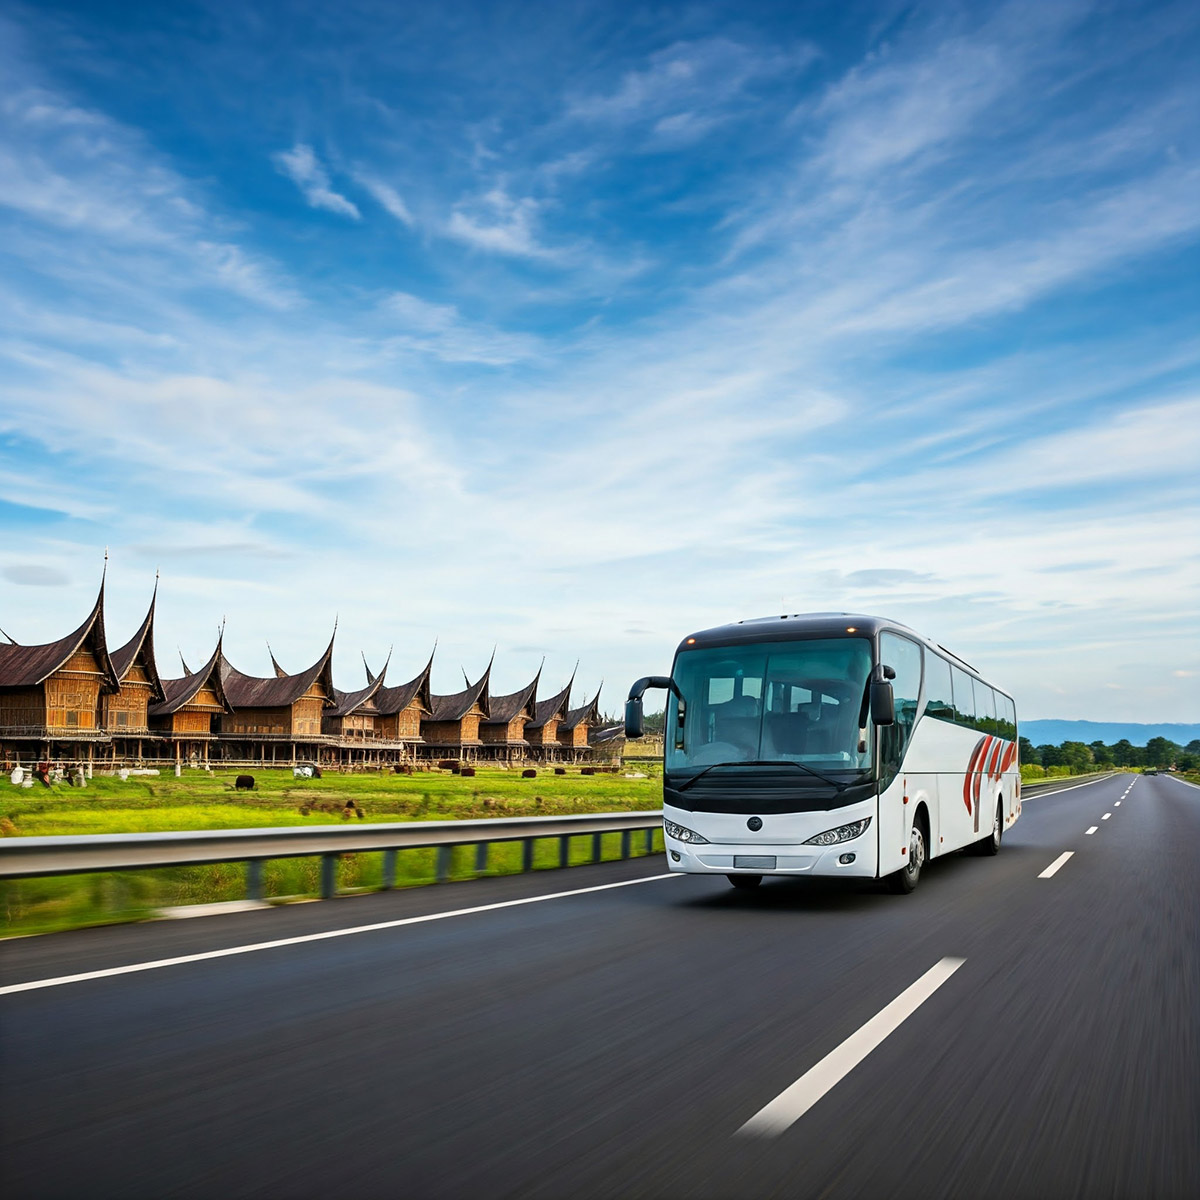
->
[0,809,662,900]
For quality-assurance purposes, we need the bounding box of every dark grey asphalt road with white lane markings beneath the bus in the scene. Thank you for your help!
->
[0,775,1200,1200]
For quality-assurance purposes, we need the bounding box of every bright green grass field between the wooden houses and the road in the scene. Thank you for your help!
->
[0,763,662,936]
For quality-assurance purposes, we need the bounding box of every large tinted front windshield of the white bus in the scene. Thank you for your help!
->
[666,637,871,779]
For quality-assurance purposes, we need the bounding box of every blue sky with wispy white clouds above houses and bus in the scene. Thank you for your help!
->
[0,0,1200,721]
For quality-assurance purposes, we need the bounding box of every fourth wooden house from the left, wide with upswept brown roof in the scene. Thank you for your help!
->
[218,629,337,763]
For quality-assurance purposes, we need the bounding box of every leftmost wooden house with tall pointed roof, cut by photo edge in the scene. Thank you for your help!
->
[0,581,120,762]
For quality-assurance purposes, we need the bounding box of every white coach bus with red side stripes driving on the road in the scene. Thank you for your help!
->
[625,613,1021,892]
